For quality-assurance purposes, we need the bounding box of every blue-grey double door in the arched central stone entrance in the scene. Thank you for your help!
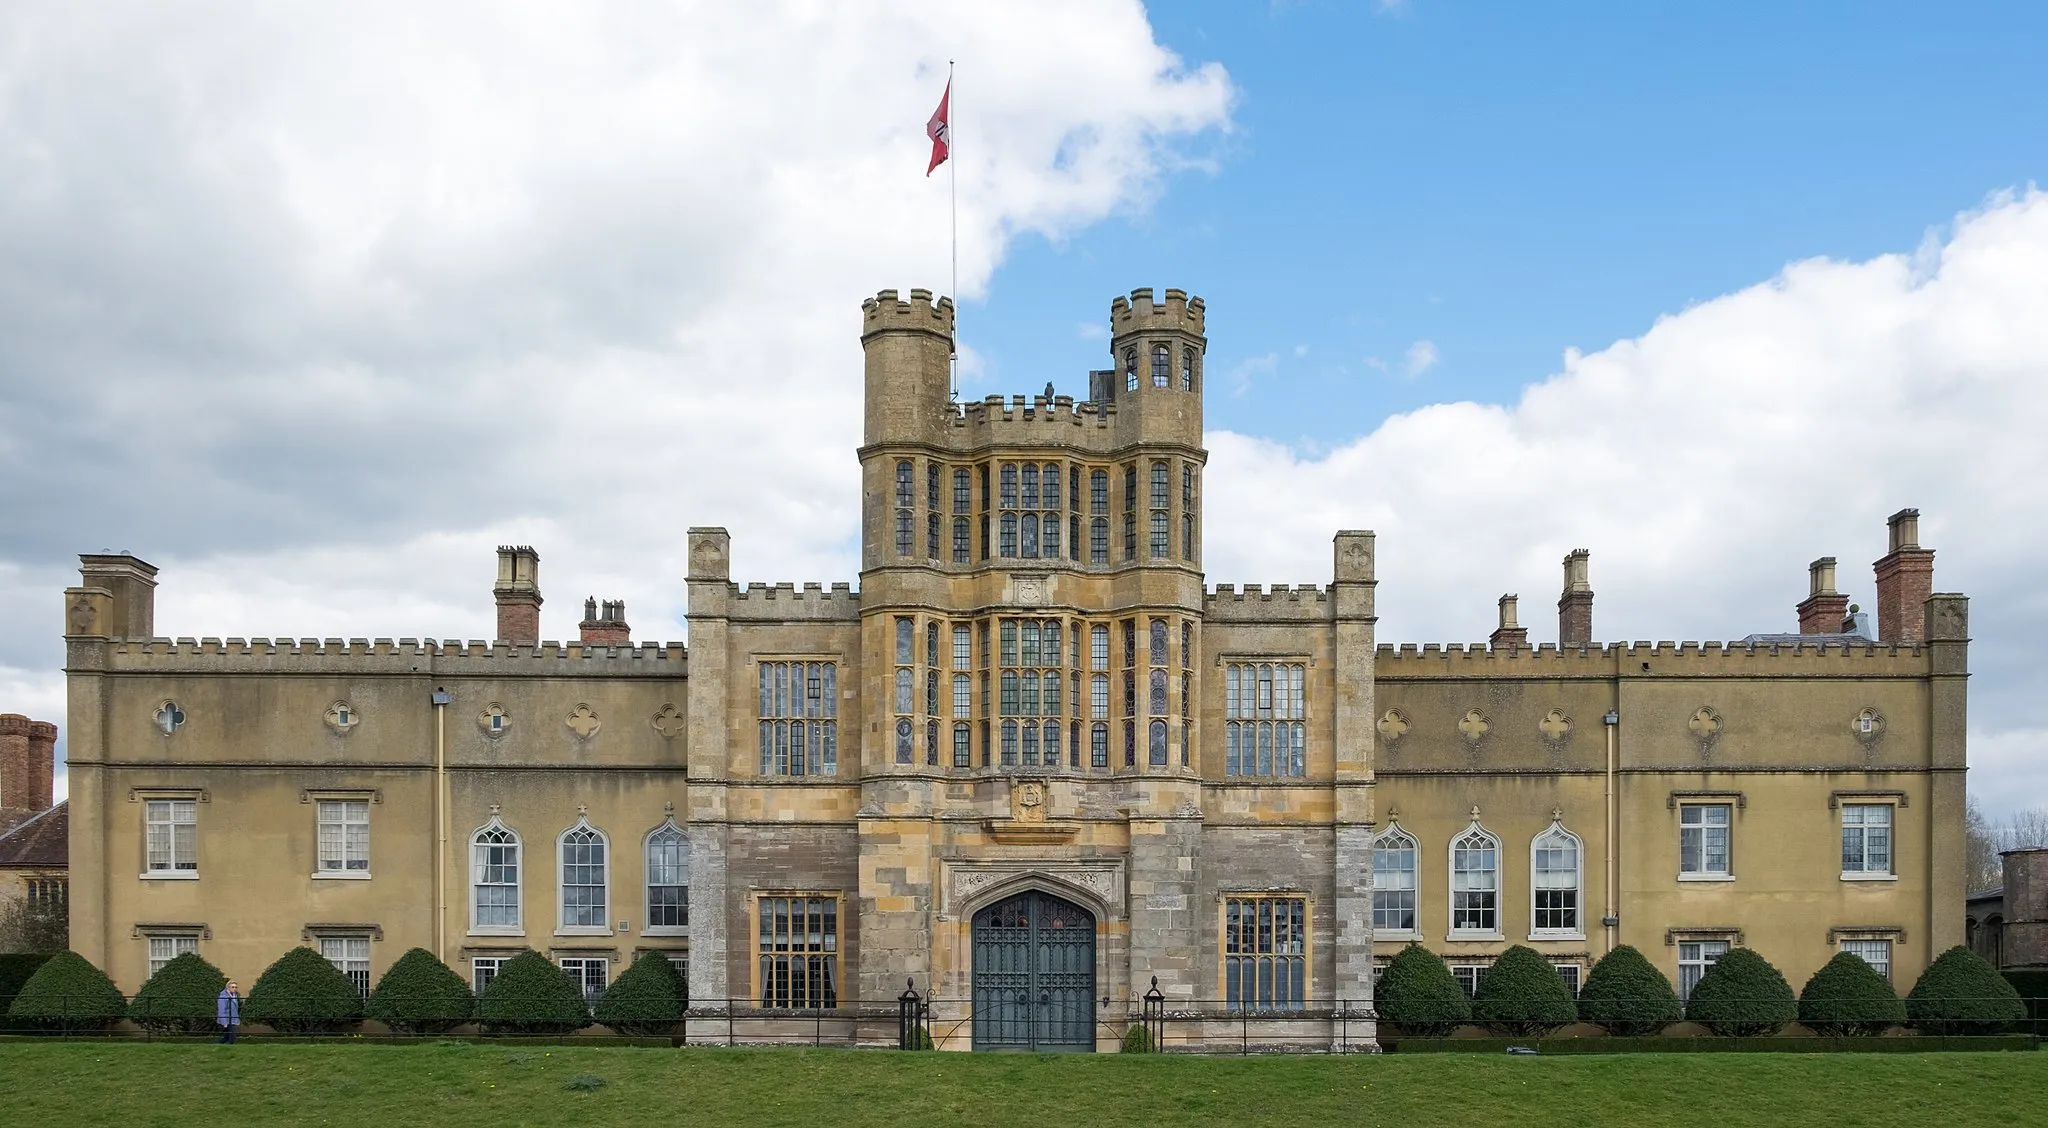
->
[973,891,1096,1050]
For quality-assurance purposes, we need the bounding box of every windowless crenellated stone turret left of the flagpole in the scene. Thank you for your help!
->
[860,291,952,446]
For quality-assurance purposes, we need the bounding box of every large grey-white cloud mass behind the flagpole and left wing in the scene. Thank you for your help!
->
[0,0,1233,786]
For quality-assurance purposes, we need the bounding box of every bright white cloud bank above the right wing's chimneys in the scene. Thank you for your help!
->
[1206,190,2048,811]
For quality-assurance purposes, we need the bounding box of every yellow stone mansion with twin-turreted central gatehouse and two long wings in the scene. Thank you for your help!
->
[63,289,1968,1050]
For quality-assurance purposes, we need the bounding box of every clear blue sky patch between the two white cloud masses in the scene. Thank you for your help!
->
[958,0,2048,448]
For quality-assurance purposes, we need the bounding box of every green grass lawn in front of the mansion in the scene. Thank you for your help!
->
[0,1042,2048,1128]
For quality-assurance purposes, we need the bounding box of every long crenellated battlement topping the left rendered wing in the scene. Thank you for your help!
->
[83,637,688,678]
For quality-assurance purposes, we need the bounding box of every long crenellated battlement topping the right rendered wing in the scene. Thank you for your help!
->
[1374,641,1927,678]
